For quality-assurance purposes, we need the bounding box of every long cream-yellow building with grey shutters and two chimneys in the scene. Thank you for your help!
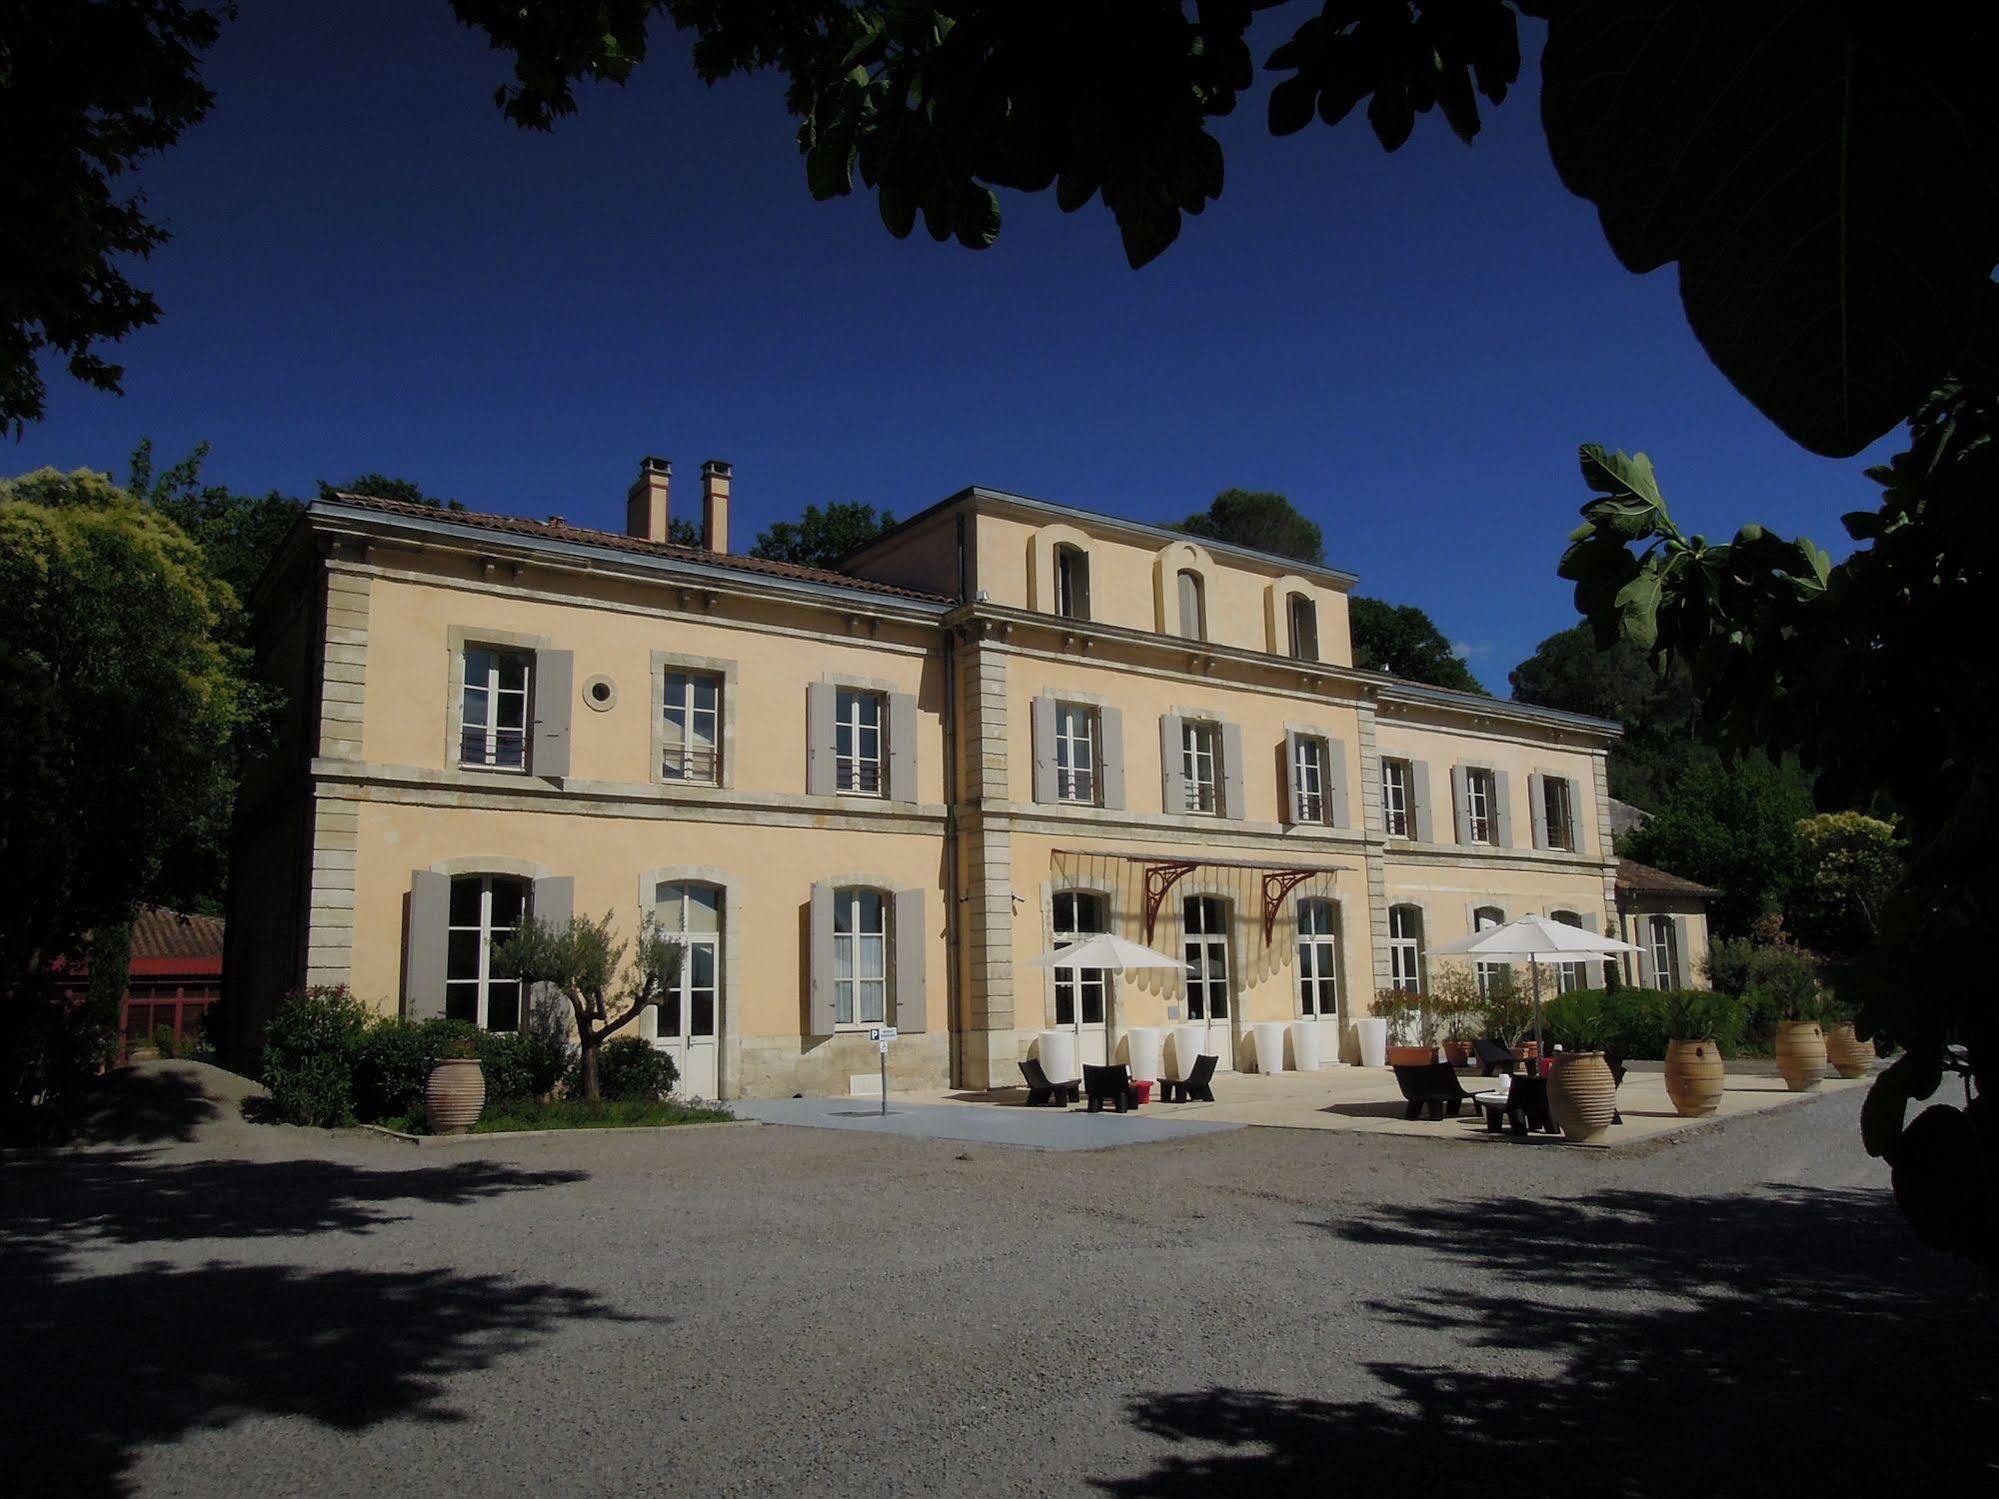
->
[230,458,1703,1097]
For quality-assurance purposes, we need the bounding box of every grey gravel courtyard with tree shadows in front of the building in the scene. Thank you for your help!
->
[0,1065,1999,1495]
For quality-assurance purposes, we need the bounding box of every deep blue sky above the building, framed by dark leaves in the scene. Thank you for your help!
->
[11,0,1899,692]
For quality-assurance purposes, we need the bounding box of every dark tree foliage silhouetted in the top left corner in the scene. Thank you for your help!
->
[0,0,234,436]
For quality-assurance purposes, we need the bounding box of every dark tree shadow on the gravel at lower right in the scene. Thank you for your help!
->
[1095,1189,1999,1499]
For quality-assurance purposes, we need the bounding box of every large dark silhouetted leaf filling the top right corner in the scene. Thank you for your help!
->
[1541,0,1999,456]
